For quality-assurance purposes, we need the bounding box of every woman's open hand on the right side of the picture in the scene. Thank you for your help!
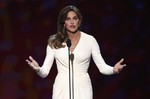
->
[113,58,126,73]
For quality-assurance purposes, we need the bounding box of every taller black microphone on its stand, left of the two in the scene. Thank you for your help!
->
[67,39,71,99]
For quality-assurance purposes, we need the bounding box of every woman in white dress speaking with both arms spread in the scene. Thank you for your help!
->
[26,6,126,99]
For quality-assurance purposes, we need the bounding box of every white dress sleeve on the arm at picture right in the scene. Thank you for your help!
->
[92,37,113,75]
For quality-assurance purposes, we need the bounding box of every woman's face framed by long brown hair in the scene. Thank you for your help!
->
[64,11,80,33]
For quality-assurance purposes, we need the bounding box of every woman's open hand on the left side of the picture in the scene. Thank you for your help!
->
[26,56,40,72]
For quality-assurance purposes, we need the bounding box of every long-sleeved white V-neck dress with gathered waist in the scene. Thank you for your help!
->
[38,32,113,99]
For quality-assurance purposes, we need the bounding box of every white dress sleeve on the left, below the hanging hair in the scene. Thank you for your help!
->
[37,45,54,78]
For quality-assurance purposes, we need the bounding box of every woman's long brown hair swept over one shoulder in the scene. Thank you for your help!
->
[48,6,82,49]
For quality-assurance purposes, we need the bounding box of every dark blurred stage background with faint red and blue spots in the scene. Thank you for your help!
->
[0,0,150,99]
